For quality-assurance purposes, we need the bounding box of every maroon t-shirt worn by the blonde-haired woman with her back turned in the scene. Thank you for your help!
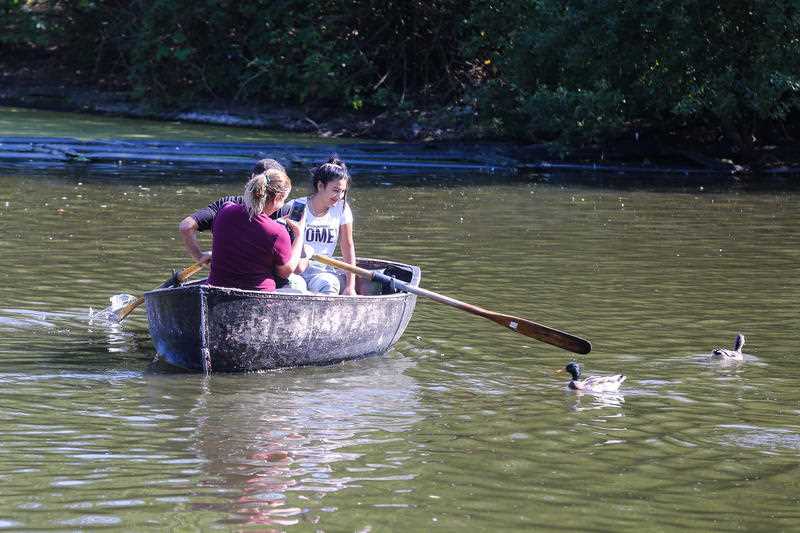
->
[208,203,292,291]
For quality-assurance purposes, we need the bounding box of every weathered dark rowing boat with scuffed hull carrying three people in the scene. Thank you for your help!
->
[144,259,421,373]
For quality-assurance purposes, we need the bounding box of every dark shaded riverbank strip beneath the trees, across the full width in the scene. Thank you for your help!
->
[0,64,800,175]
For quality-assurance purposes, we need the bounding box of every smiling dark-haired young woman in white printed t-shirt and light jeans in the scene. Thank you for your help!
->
[280,156,356,294]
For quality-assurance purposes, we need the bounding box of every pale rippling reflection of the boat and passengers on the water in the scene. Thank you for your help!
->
[148,353,421,526]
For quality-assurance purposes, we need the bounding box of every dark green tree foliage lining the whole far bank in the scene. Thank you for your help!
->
[0,0,800,151]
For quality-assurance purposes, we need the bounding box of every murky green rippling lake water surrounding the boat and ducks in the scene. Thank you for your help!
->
[0,111,800,531]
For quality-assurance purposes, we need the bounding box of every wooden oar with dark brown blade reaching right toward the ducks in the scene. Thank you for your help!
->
[311,254,592,354]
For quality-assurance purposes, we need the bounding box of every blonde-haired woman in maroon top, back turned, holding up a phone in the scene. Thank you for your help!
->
[208,169,305,291]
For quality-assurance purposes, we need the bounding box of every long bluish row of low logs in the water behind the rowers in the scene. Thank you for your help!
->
[0,136,776,176]
